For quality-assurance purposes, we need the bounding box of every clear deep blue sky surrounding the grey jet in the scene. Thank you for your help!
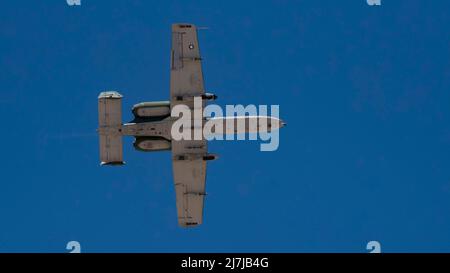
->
[0,0,450,252]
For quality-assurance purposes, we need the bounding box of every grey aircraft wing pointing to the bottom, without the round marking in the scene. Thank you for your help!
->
[172,140,207,227]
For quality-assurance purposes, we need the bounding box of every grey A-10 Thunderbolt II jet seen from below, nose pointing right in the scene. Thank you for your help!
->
[98,24,285,227]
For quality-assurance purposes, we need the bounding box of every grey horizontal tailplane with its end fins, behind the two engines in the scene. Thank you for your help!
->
[98,91,124,165]
